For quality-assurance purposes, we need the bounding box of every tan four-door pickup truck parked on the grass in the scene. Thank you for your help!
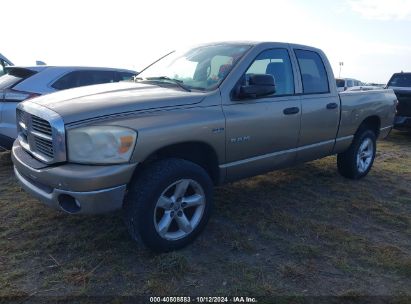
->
[12,42,397,252]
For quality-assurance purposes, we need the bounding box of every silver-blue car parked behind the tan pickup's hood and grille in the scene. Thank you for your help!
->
[0,66,137,149]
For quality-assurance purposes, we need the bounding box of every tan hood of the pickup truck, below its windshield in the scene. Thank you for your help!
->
[27,82,205,124]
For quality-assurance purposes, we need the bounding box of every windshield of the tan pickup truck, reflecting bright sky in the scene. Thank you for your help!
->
[136,44,250,91]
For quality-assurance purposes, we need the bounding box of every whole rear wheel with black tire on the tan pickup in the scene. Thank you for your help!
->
[337,129,376,179]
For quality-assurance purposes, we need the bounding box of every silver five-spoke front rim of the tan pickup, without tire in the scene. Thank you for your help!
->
[154,179,206,241]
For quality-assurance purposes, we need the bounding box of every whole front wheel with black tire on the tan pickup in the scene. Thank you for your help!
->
[123,159,213,252]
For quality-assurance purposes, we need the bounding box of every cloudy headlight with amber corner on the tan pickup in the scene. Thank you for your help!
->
[67,126,137,164]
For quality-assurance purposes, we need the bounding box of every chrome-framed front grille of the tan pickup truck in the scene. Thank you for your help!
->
[16,103,66,164]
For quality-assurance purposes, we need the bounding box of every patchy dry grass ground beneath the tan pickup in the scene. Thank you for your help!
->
[0,132,411,299]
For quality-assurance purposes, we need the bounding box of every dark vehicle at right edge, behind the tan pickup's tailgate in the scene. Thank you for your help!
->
[387,72,411,131]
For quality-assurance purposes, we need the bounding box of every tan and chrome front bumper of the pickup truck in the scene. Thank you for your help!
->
[12,141,136,214]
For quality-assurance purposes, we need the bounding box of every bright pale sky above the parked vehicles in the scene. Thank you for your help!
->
[0,0,411,83]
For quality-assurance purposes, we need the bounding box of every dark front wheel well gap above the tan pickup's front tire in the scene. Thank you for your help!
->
[142,142,219,185]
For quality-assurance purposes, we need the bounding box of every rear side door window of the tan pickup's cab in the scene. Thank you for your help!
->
[294,49,330,94]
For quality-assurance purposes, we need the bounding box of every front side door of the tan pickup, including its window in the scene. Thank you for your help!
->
[223,48,301,180]
